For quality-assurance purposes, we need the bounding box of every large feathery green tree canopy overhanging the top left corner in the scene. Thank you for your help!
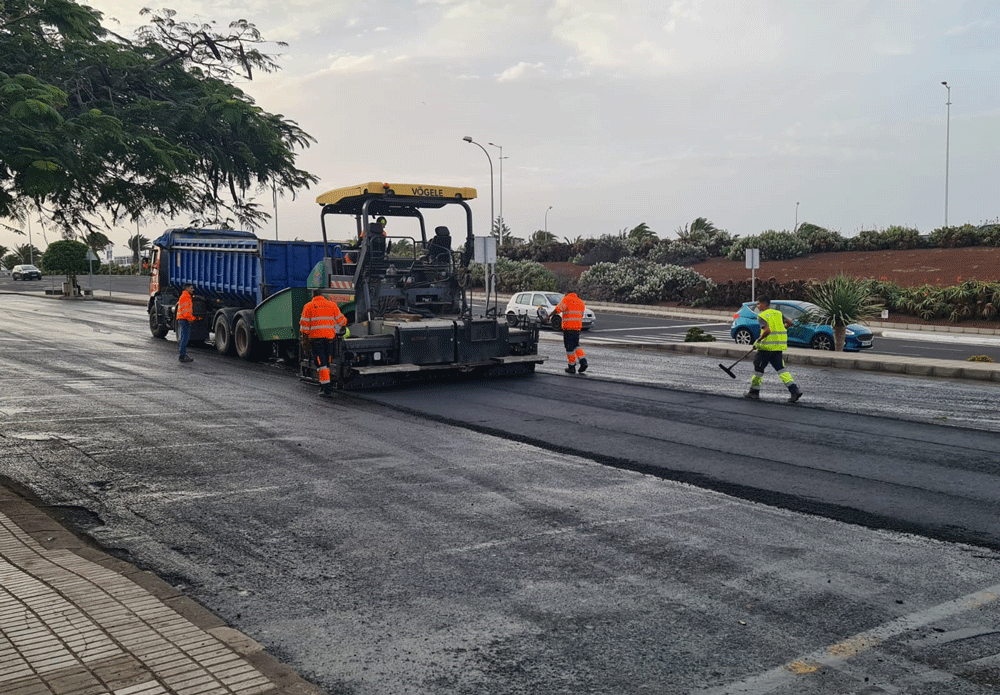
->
[0,0,317,237]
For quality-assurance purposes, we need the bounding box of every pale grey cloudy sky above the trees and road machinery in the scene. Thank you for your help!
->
[0,0,1000,254]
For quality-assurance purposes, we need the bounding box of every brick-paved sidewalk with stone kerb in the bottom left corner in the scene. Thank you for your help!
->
[0,486,321,695]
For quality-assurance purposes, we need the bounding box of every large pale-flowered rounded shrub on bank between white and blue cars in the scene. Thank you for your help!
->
[578,258,714,304]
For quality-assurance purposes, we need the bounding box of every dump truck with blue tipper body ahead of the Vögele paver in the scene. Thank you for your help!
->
[148,228,324,359]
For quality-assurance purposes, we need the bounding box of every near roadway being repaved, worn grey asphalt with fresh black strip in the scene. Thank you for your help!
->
[0,296,1000,695]
